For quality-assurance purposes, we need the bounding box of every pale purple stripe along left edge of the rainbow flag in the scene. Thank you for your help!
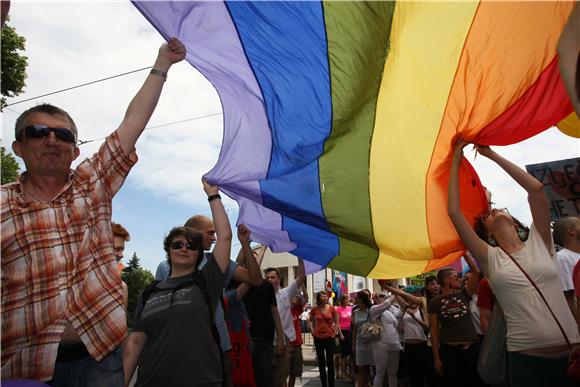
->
[133,1,296,251]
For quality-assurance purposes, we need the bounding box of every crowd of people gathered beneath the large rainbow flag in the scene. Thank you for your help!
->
[1,19,580,387]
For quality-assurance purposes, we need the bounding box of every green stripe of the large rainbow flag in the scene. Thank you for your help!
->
[319,2,395,273]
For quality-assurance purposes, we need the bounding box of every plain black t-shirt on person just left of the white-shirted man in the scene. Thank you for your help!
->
[244,280,276,343]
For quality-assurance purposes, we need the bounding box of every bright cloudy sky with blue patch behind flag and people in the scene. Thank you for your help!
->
[1,0,580,278]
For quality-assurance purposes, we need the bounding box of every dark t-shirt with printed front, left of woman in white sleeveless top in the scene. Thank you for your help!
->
[429,288,477,343]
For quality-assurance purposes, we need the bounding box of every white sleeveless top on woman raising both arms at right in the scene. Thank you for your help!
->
[480,224,580,352]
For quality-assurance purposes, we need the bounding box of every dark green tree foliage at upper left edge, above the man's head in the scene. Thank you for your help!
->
[0,24,28,108]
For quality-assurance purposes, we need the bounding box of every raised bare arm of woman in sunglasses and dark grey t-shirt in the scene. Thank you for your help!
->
[202,179,232,273]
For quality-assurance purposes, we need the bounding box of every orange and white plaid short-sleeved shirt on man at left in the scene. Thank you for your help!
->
[0,132,137,380]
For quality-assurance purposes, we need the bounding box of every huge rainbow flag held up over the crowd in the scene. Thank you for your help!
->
[134,1,574,278]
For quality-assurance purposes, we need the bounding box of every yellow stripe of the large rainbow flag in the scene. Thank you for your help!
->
[369,2,478,278]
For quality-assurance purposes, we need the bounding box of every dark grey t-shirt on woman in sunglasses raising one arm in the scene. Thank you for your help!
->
[133,256,224,387]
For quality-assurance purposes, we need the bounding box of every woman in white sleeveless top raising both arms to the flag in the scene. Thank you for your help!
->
[448,140,580,387]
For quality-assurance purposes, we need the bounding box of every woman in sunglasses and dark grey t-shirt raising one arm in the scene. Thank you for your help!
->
[123,180,232,387]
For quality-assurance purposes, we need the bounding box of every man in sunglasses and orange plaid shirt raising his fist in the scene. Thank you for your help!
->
[0,38,185,386]
